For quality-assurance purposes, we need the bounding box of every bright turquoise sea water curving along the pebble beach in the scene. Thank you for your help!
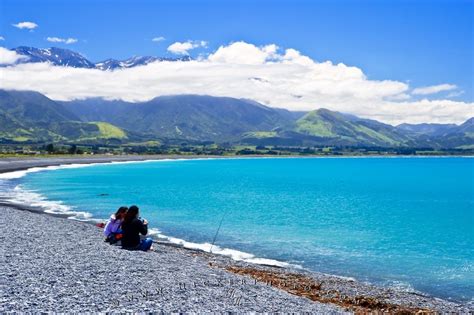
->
[3,158,474,301]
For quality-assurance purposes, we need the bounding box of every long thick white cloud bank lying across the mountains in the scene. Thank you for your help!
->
[0,42,474,124]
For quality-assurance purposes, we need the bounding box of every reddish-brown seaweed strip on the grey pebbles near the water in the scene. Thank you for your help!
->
[225,266,435,315]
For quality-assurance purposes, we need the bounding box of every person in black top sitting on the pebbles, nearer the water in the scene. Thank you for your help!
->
[122,206,153,251]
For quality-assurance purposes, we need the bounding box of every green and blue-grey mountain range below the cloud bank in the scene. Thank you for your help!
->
[0,90,474,149]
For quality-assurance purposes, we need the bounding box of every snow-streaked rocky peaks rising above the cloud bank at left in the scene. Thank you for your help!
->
[12,46,191,70]
